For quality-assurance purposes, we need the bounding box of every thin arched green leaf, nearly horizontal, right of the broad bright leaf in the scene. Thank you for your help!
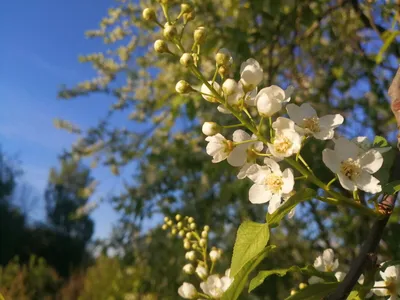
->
[249,265,337,292]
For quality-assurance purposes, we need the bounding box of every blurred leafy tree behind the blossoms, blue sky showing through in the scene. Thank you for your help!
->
[57,0,400,299]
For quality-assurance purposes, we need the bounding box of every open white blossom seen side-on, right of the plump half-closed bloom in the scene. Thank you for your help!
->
[286,103,344,140]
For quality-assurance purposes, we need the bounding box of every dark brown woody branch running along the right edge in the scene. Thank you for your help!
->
[324,64,400,300]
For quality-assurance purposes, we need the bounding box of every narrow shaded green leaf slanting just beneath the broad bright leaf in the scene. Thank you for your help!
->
[221,245,276,300]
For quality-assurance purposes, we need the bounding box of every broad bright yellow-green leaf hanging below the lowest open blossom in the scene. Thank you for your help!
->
[231,221,269,277]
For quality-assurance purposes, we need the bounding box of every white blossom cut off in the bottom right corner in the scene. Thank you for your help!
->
[372,266,400,300]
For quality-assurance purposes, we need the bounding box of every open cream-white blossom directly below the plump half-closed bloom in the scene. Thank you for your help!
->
[268,125,302,159]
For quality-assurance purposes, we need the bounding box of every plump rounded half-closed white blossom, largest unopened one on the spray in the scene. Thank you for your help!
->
[255,85,290,117]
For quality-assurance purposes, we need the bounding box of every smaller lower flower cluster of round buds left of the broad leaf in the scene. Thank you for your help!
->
[162,215,233,299]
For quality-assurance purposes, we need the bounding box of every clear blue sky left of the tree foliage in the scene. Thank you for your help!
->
[0,0,123,237]
